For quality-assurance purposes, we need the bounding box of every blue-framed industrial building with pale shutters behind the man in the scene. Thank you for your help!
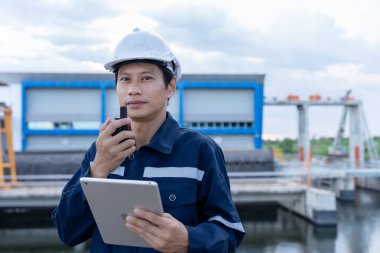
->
[0,73,264,151]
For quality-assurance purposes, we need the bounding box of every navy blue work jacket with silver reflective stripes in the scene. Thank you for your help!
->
[52,113,245,253]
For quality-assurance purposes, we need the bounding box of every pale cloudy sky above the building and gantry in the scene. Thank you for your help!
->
[0,0,380,137]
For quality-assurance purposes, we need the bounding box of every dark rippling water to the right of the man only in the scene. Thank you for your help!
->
[238,189,380,253]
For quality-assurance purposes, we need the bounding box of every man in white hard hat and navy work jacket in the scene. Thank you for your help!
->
[52,29,244,253]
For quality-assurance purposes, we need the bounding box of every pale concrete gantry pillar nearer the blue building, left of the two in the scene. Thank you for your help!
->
[297,103,311,161]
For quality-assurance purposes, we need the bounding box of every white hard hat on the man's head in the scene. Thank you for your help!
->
[104,28,181,81]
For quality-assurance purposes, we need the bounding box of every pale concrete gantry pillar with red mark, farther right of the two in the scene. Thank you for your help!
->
[349,104,364,168]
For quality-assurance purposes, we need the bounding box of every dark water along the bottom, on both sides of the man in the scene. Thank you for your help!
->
[0,190,380,253]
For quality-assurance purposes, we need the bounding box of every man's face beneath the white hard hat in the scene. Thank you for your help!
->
[116,62,175,122]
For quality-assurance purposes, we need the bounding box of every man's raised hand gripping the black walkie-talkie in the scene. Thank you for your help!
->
[90,118,136,178]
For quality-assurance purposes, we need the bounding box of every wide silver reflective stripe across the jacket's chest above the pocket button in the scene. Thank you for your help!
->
[143,167,205,181]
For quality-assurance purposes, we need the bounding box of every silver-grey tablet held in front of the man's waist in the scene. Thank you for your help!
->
[80,177,163,247]
